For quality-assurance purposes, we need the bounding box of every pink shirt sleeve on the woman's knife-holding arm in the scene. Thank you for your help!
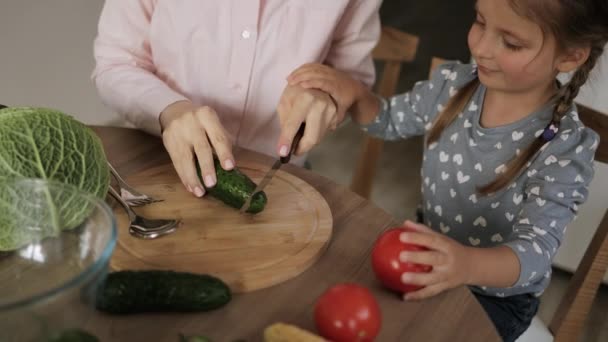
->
[325,0,381,87]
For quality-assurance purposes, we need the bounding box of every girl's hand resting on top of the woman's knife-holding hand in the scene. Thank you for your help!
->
[287,63,365,123]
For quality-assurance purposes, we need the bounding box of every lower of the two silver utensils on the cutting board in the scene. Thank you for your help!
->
[108,186,180,239]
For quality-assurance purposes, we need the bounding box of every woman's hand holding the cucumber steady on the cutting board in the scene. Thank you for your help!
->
[159,101,235,197]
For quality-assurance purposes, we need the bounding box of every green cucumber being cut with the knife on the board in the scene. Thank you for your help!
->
[195,155,268,214]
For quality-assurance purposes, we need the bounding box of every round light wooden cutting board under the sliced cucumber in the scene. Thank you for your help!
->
[111,163,332,292]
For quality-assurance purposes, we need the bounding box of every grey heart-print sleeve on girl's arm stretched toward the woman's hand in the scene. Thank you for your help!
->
[362,63,476,140]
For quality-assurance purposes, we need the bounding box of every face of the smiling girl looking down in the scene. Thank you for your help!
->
[468,0,557,92]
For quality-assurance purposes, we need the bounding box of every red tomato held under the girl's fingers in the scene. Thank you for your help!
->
[372,227,432,293]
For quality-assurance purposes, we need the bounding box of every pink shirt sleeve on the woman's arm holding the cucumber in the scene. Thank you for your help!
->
[92,0,186,135]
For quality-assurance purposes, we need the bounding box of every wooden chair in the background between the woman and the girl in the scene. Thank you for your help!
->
[350,27,418,199]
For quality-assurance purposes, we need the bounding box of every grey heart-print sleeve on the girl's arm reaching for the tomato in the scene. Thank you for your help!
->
[506,118,599,287]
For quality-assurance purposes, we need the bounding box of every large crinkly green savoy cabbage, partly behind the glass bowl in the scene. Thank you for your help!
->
[0,107,110,251]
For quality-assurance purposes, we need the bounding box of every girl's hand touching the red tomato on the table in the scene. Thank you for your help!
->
[399,221,472,300]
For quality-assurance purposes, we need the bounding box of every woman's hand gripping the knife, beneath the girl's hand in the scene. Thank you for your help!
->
[277,85,340,157]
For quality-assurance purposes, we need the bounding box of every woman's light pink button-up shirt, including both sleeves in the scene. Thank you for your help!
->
[93,0,381,159]
